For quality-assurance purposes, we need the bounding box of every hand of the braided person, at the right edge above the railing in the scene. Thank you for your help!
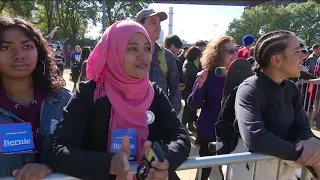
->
[296,137,320,166]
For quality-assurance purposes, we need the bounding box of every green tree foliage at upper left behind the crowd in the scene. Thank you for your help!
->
[0,0,149,46]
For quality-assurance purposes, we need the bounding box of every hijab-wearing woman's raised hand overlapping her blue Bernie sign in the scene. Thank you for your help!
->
[110,136,132,180]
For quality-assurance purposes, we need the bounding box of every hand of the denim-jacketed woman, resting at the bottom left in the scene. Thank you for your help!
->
[12,163,52,180]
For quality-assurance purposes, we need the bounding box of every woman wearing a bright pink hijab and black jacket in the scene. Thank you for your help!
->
[49,20,190,180]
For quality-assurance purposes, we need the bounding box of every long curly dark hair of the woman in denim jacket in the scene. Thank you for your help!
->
[0,15,65,93]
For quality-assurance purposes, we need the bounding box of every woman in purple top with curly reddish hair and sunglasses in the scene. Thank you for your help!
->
[187,36,237,179]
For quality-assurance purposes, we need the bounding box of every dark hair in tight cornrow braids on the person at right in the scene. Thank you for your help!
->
[253,30,295,72]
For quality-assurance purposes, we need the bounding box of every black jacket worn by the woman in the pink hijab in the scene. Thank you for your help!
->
[49,81,191,180]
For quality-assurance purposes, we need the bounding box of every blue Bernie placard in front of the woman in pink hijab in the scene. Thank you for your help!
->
[111,129,137,161]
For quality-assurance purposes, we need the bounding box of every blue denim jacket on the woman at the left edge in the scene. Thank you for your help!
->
[0,89,71,177]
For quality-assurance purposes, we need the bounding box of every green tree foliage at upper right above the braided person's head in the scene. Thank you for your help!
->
[227,1,320,45]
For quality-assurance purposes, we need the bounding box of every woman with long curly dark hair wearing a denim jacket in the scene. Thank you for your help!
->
[0,16,71,180]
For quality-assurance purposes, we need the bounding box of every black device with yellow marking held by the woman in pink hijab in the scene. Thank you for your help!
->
[136,142,165,180]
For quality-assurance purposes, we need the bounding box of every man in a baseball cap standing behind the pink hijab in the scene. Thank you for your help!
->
[136,9,181,114]
